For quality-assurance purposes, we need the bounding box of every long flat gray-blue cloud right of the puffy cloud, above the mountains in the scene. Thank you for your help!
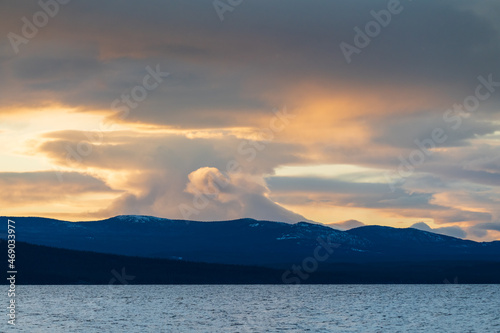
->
[267,177,493,223]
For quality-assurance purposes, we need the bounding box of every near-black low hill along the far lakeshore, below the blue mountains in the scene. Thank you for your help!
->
[0,241,500,285]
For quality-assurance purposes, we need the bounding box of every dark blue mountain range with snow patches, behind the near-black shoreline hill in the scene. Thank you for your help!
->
[0,215,500,268]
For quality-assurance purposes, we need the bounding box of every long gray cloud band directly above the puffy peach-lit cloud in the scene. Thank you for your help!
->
[33,131,303,176]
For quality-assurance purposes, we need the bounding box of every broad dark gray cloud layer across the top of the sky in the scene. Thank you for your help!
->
[0,0,500,122]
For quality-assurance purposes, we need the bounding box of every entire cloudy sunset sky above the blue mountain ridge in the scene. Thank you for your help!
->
[0,0,500,241]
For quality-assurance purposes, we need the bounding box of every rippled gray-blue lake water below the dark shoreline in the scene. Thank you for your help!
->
[8,284,500,333]
